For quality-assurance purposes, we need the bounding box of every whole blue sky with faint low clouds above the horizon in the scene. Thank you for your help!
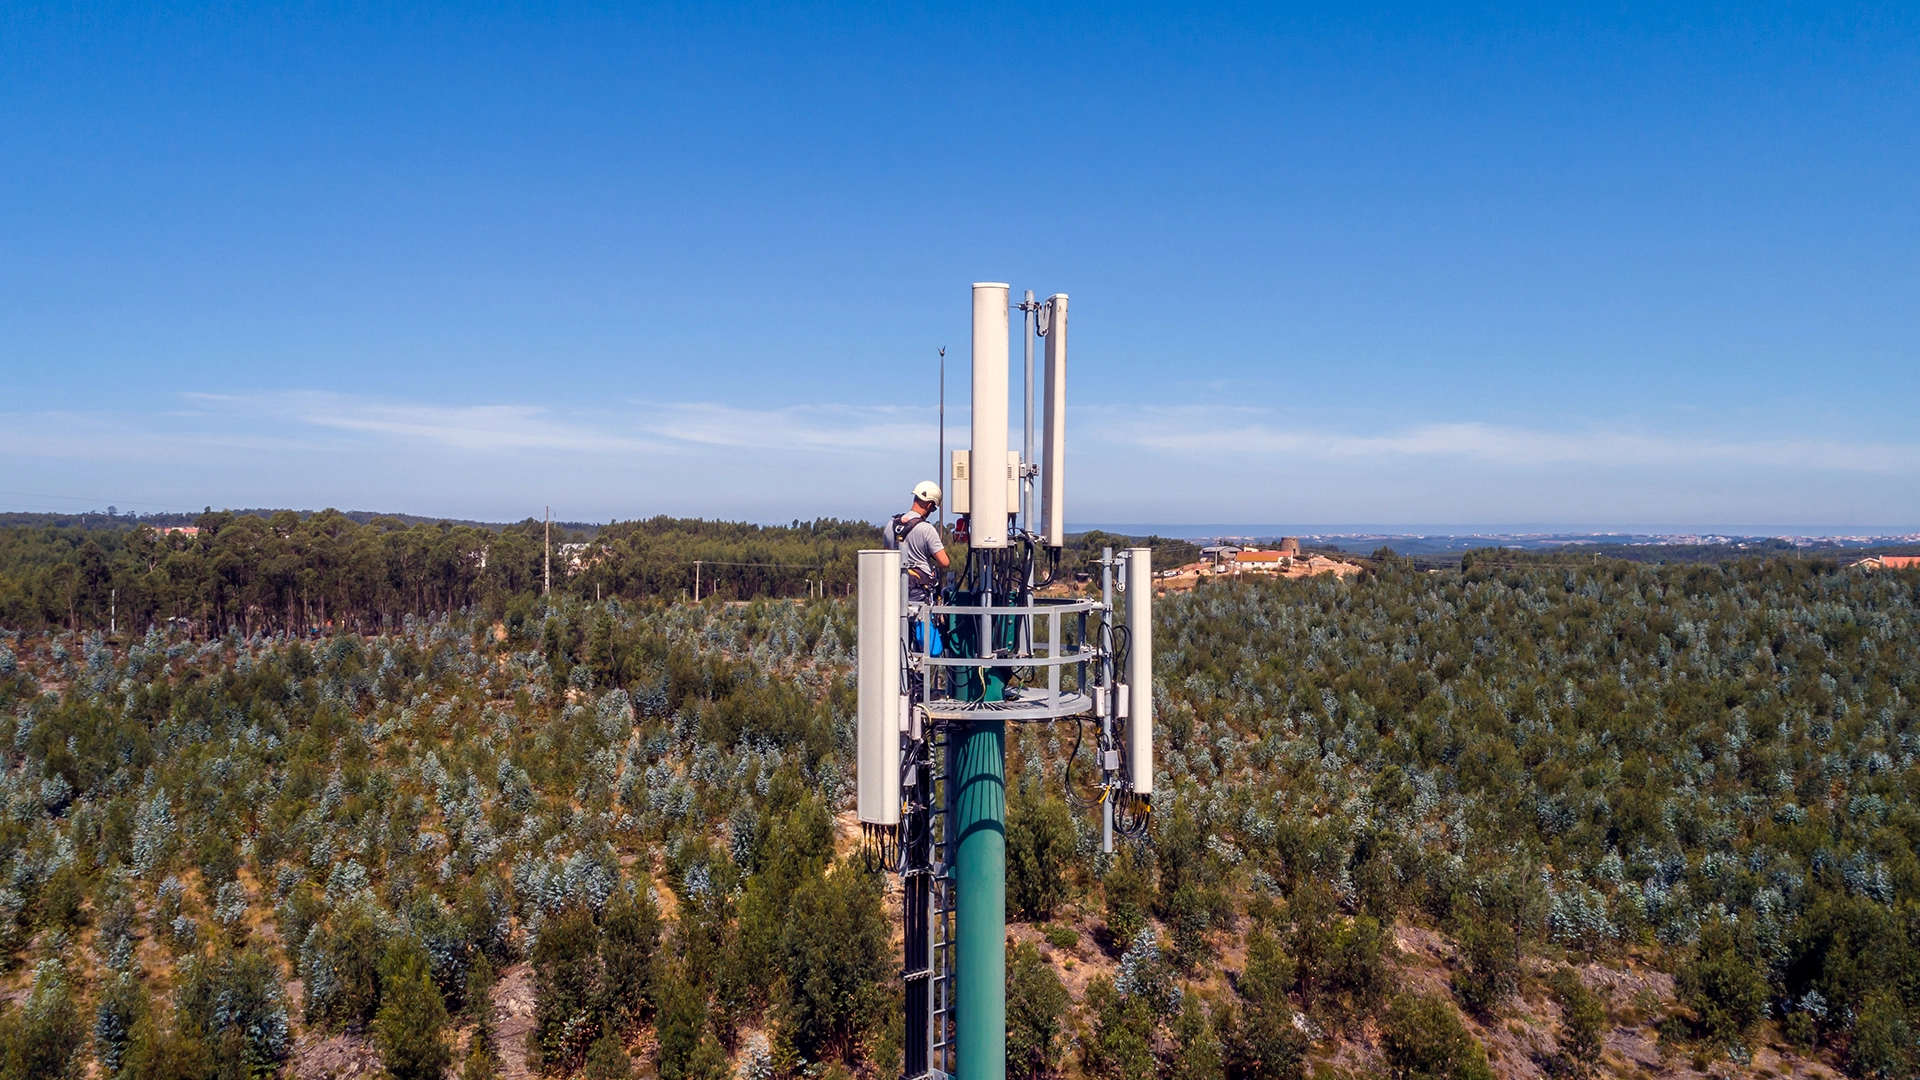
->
[0,4,1920,530]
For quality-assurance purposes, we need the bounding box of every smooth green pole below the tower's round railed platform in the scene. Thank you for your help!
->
[950,721,1006,1080]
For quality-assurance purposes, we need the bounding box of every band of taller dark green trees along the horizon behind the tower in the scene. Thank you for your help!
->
[0,509,1198,638]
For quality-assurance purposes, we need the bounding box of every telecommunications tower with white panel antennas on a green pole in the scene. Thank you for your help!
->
[858,282,1154,1080]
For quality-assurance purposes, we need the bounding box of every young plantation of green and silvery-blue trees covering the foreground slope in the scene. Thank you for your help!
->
[0,545,1920,1080]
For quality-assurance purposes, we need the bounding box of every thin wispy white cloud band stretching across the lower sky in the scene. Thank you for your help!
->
[15,390,1920,475]
